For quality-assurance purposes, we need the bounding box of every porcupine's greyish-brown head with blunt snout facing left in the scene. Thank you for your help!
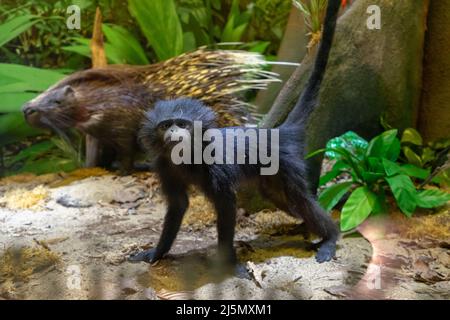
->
[22,85,77,129]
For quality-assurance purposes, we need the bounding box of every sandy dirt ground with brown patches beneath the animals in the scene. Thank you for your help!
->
[0,169,450,299]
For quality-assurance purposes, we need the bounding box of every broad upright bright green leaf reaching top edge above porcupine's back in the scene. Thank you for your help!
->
[128,0,183,60]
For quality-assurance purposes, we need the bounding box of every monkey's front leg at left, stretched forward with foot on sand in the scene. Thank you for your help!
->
[128,190,189,263]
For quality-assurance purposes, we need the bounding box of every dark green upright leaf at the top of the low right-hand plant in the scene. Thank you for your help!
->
[366,129,400,161]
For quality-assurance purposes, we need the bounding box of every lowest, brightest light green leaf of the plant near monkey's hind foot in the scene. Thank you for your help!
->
[341,186,376,231]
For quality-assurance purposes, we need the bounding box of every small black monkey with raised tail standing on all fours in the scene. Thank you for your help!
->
[130,0,340,265]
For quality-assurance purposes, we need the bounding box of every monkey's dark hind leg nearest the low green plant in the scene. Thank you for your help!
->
[285,178,339,263]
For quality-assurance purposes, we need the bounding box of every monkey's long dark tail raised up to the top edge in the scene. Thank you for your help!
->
[282,0,341,126]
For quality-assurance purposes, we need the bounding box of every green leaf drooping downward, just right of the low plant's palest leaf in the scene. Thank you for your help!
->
[386,174,417,217]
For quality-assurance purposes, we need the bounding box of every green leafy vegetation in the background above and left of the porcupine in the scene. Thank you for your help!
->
[0,0,291,175]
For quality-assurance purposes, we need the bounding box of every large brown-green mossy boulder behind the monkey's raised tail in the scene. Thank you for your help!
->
[278,0,428,188]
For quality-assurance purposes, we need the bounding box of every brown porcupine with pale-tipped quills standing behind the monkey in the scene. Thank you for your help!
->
[22,48,279,173]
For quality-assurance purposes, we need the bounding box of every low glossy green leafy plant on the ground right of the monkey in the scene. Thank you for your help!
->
[310,130,450,231]
